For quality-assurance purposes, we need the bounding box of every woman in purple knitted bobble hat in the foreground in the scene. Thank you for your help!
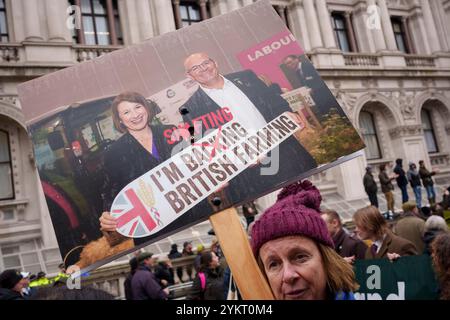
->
[251,180,358,300]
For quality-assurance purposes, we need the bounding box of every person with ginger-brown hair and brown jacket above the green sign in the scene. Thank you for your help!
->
[353,206,419,260]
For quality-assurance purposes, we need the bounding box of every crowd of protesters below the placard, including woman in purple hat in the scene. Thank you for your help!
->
[0,178,450,300]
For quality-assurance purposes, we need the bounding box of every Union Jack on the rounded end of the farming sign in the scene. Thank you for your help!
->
[111,188,160,238]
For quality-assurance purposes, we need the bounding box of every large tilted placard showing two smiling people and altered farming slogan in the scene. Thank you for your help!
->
[18,1,364,271]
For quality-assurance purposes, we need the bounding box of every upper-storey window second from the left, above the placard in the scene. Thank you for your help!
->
[70,0,123,45]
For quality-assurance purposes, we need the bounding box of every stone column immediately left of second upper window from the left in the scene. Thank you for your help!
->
[45,0,71,41]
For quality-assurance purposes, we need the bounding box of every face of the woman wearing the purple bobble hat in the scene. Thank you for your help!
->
[259,236,326,300]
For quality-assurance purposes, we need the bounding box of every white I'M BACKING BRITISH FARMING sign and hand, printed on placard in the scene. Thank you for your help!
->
[110,113,302,238]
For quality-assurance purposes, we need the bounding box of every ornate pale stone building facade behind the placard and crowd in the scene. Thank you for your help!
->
[0,0,450,272]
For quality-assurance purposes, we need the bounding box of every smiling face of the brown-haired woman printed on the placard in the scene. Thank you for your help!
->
[117,101,148,131]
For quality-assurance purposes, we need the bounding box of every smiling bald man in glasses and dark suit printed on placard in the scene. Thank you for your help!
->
[180,53,317,203]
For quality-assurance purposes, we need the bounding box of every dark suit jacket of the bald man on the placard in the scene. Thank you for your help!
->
[180,70,317,204]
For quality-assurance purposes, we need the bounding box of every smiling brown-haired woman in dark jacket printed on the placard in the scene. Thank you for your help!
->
[100,92,172,245]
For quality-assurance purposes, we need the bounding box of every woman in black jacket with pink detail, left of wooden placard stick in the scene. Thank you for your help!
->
[188,251,224,300]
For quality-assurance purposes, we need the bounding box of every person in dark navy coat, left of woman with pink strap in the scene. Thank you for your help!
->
[131,252,169,300]
